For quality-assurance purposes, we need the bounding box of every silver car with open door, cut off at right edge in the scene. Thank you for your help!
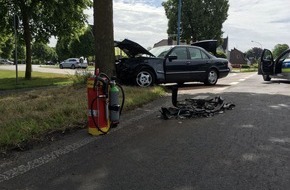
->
[258,49,290,81]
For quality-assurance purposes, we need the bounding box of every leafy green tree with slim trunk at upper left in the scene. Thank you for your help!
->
[0,0,91,79]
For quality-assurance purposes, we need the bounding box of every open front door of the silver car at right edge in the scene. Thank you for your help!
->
[258,49,274,77]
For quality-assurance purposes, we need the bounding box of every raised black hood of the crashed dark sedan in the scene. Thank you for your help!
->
[115,39,155,57]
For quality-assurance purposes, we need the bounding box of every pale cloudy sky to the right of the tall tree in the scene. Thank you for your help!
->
[223,0,290,51]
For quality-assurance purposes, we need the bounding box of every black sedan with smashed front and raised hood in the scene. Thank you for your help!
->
[115,39,230,87]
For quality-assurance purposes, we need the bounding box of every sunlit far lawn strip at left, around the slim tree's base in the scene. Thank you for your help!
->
[0,70,72,90]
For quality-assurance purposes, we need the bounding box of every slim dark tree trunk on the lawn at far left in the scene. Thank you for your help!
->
[21,4,32,79]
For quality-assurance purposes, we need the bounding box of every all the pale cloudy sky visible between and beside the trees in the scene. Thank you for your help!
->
[51,0,290,52]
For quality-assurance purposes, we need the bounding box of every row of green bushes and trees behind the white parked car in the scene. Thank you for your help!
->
[0,26,94,64]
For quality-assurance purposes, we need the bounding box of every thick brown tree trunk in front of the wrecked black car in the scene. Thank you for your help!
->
[94,0,115,76]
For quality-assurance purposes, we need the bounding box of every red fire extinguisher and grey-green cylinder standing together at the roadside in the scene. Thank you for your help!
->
[87,70,124,135]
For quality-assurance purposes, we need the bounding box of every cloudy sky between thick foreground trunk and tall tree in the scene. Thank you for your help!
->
[86,0,168,48]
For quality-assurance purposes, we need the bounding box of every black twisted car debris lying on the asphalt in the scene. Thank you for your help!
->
[160,87,235,119]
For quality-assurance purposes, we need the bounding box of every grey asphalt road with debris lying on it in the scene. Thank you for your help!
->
[0,73,290,190]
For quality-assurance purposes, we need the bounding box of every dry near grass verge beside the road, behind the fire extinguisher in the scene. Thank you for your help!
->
[0,84,164,151]
